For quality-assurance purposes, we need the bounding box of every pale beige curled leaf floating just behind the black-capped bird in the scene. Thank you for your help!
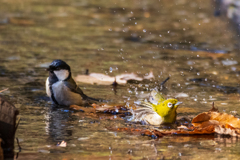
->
[75,72,154,85]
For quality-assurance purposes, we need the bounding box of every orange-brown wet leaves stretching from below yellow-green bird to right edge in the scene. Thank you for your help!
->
[108,103,240,138]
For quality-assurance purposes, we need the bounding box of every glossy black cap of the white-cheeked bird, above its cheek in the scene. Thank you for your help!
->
[47,59,71,72]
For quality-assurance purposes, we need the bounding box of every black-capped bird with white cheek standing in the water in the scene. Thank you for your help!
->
[46,60,100,106]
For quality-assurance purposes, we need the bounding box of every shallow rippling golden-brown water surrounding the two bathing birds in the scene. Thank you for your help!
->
[0,0,240,160]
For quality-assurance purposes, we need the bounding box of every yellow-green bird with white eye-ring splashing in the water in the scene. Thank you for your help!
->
[132,90,182,126]
